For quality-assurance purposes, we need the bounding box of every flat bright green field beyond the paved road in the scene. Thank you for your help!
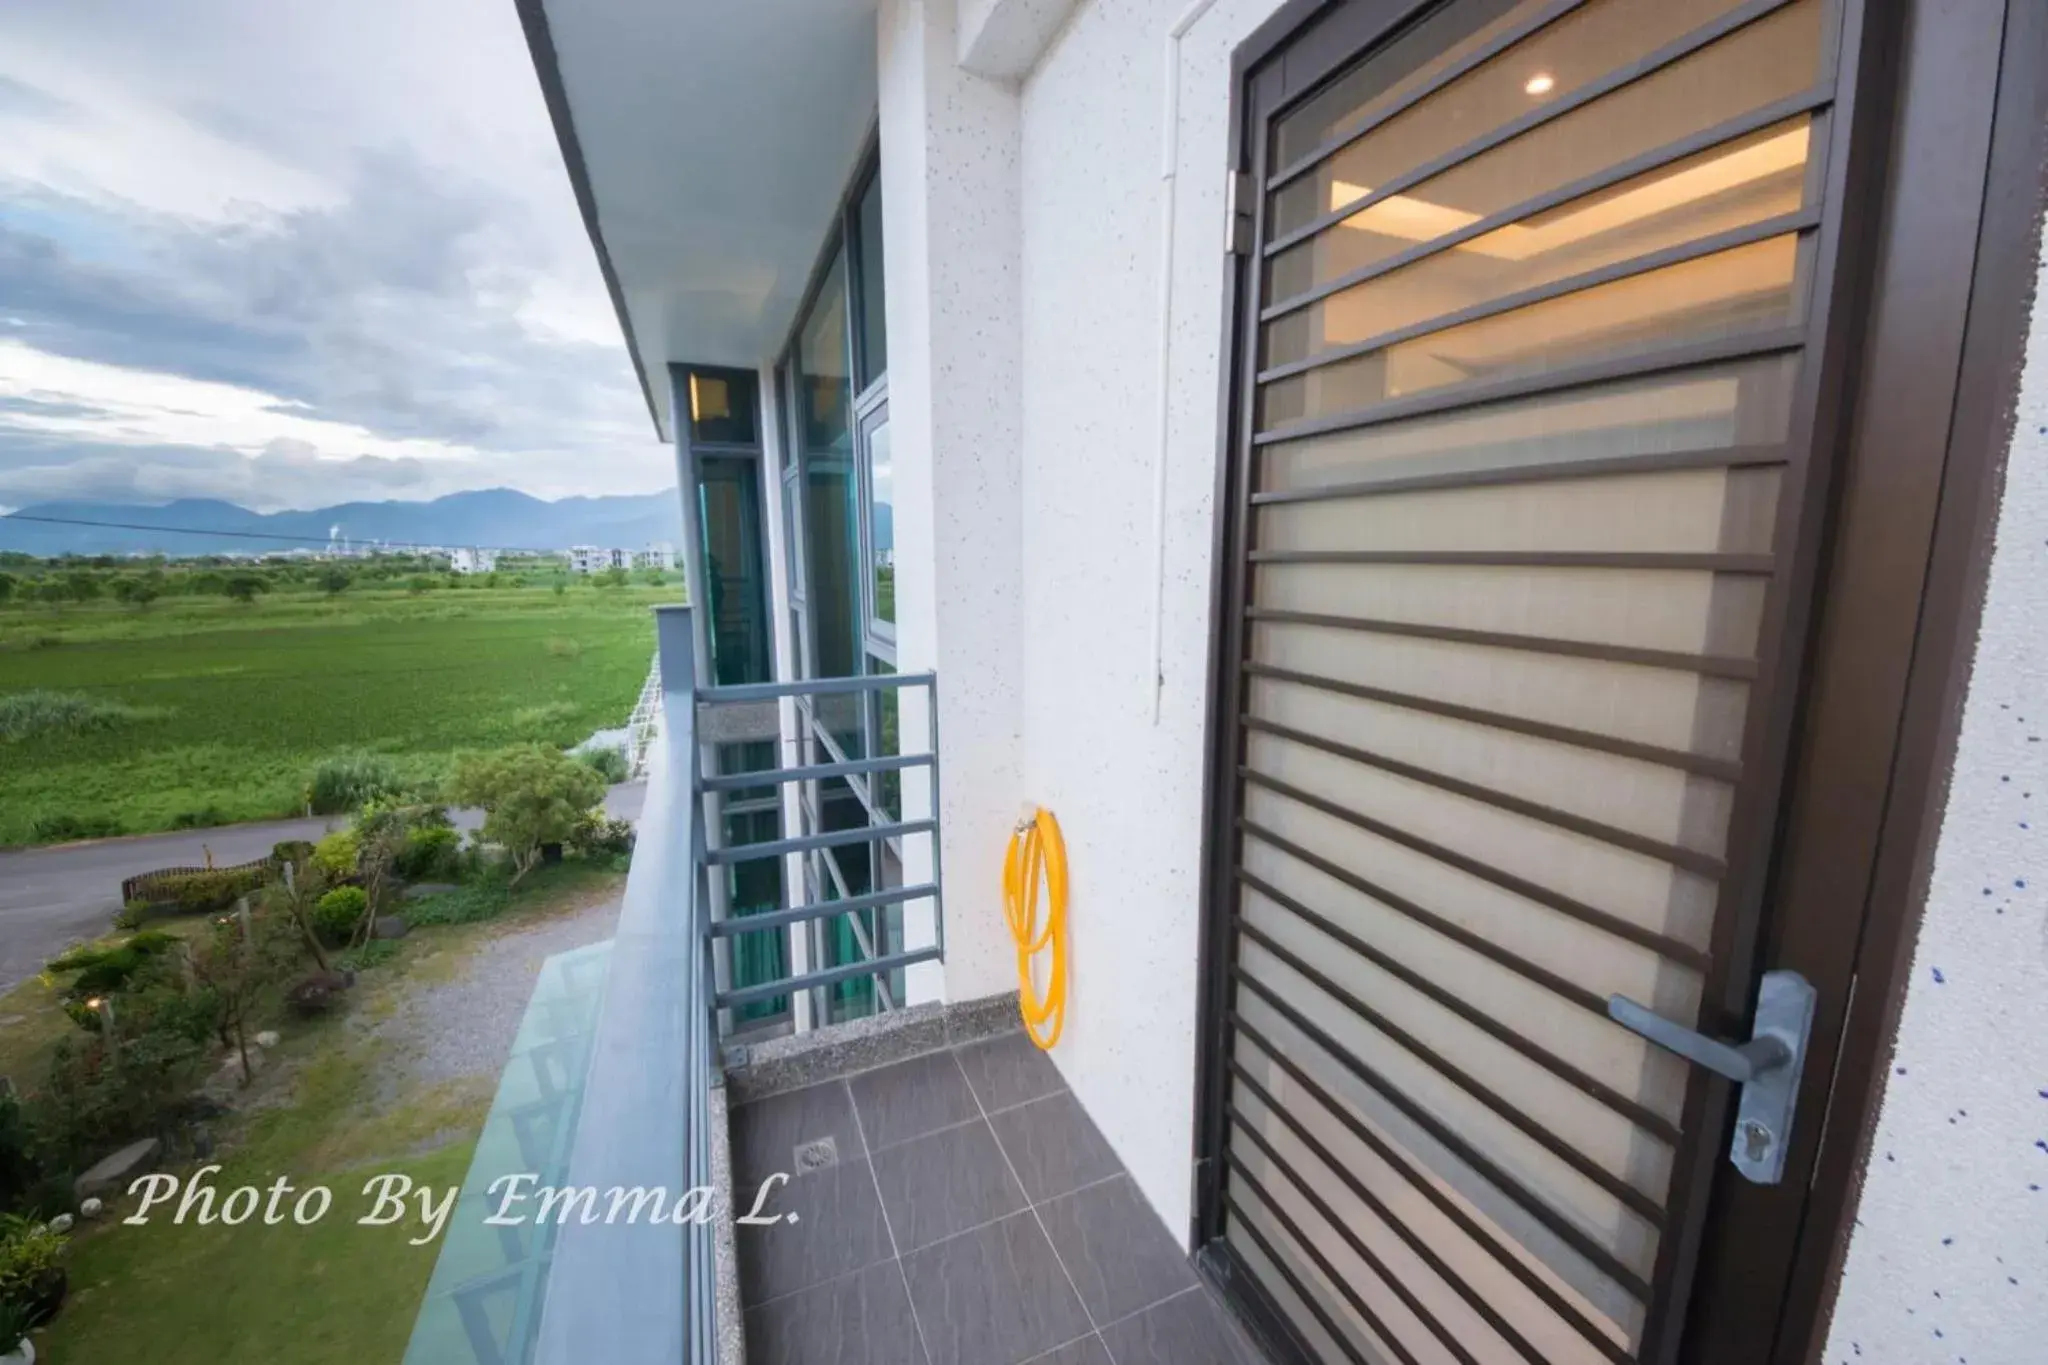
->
[0,583,663,847]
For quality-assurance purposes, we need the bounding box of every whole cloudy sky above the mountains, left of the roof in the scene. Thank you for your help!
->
[0,0,674,510]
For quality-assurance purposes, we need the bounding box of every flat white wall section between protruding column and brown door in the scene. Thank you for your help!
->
[1022,0,1276,1236]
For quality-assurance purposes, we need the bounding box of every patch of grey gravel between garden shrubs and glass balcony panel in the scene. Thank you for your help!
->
[369,898,618,1097]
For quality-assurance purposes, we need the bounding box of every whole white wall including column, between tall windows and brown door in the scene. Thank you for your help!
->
[879,0,1276,1236]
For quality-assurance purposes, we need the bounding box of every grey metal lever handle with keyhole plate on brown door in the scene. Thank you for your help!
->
[1608,972,1815,1185]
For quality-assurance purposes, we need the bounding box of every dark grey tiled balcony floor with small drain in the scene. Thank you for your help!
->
[731,1033,1264,1365]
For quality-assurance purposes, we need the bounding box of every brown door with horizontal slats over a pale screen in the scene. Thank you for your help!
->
[1198,0,1900,1365]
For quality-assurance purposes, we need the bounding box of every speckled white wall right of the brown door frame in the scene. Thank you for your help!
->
[1825,218,2048,1365]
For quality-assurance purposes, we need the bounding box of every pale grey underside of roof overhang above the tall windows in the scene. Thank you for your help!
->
[514,0,874,440]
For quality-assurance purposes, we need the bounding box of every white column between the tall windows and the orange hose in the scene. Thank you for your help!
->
[877,0,1026,1003]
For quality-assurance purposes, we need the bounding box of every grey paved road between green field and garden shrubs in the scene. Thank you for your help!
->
[0,782,647,990]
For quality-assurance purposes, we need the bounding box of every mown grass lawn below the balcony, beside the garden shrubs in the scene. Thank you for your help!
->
[22,864,625,1365]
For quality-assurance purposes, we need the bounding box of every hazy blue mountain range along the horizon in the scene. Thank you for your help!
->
[0,489,682,555]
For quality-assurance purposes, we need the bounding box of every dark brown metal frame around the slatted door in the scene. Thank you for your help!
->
[1192,0,2048,1365]
